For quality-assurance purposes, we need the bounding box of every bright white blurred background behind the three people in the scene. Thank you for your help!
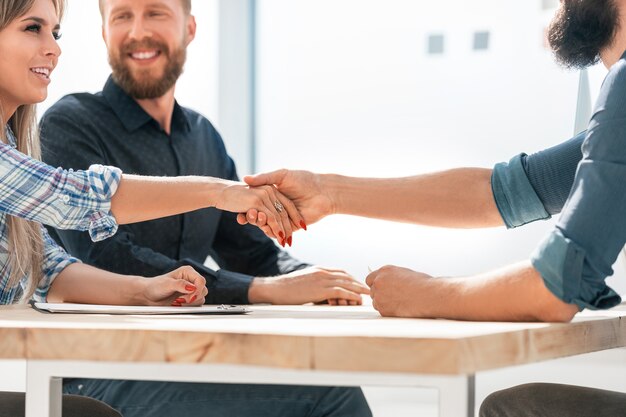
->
[0,0,626,417]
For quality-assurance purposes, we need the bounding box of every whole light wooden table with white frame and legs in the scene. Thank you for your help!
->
[0,306,626,417]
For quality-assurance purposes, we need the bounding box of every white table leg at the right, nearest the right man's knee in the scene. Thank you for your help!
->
[439,375,476,417]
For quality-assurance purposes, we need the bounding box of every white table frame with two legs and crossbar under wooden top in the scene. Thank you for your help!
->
[26,360,475,417]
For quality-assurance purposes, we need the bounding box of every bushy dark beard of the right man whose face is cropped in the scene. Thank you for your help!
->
[548,0,620,68]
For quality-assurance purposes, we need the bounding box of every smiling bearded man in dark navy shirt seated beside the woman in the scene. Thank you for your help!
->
[37,0,371,417]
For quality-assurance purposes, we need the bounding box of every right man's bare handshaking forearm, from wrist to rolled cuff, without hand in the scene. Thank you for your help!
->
[321,168,504,228]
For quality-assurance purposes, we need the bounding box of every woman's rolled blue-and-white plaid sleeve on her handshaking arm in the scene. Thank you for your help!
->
[0,144,122,241]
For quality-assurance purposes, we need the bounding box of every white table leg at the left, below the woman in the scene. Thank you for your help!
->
[26,361,63,417]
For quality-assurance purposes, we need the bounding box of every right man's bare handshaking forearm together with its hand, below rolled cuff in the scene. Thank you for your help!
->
[244,168,503,228]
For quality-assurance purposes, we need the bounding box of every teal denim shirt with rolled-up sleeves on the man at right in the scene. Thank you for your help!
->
[492,54,626,309]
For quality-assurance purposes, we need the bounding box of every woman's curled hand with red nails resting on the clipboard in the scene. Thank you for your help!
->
[144,266,208,307]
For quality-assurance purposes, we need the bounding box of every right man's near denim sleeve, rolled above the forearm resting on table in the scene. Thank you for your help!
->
[531,59,626,309]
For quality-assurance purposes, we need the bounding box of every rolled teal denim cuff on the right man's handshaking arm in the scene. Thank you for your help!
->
[491,153,550,229]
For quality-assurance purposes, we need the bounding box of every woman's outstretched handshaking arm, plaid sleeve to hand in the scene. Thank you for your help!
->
[0,137,299,239]
